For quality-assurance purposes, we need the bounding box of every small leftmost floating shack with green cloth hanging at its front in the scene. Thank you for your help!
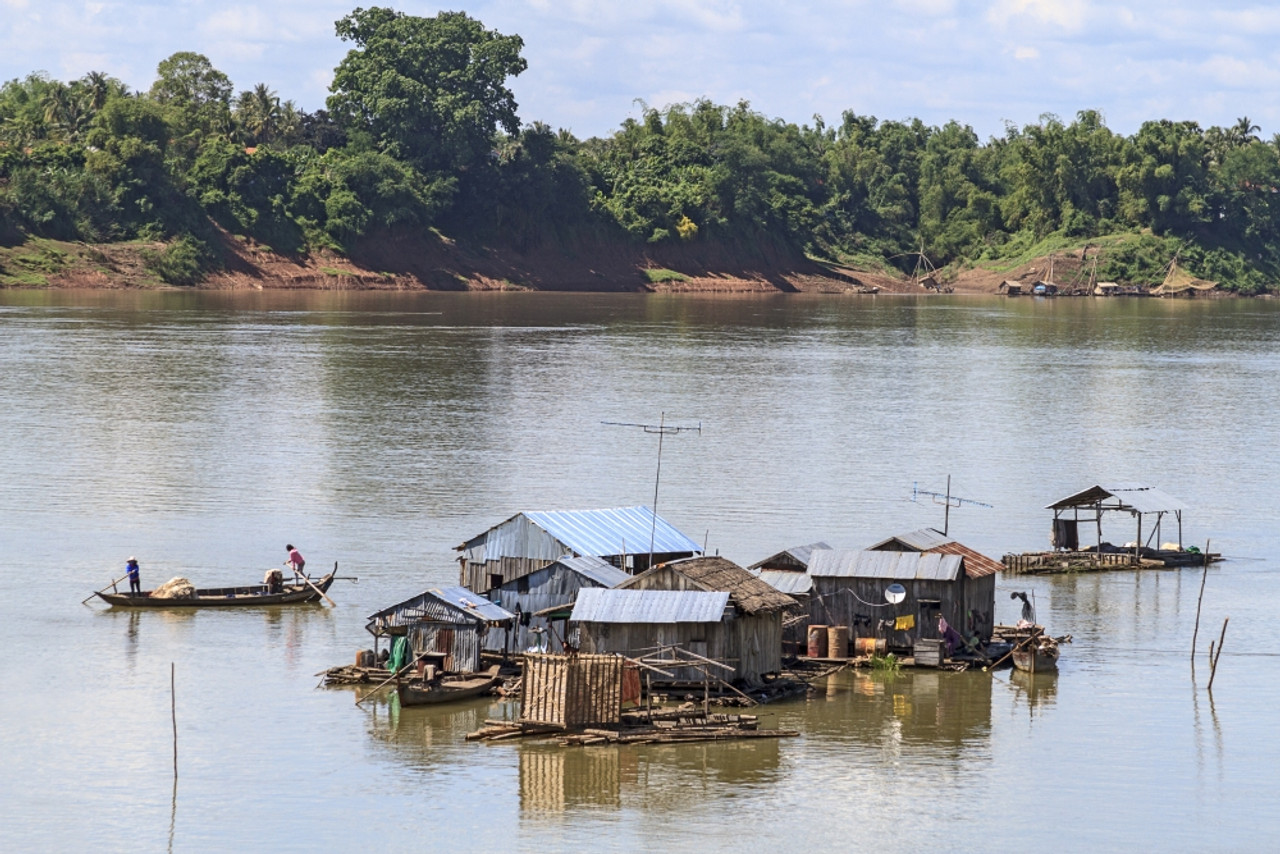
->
[365,588,516,673]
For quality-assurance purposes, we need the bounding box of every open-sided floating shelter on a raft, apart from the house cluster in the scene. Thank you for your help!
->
[1004,483,1222,574]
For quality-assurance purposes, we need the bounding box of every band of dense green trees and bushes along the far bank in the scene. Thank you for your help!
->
[0,6,1280,292]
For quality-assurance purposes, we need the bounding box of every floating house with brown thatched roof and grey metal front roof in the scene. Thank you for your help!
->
[572,557,796,684]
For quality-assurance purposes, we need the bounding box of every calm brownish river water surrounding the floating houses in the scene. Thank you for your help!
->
[0,292,1280,851]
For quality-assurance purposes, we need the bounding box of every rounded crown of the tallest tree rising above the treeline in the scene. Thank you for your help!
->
[328,6,527,172]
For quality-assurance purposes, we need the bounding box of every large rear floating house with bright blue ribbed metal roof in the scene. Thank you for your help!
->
[457,507,701,590]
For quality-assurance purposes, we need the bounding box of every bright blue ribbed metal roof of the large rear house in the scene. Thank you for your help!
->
[525,506,703,557]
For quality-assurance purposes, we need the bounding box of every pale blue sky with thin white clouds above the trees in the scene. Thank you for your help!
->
[0,0,1280,138]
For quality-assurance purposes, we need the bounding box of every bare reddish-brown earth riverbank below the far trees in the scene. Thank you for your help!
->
[0,232,1239,294]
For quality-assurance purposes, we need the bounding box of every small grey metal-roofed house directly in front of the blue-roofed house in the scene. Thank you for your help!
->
[484,554,631,652]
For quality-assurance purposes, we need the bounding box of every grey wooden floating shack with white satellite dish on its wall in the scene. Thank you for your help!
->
[809,549,996,653]
